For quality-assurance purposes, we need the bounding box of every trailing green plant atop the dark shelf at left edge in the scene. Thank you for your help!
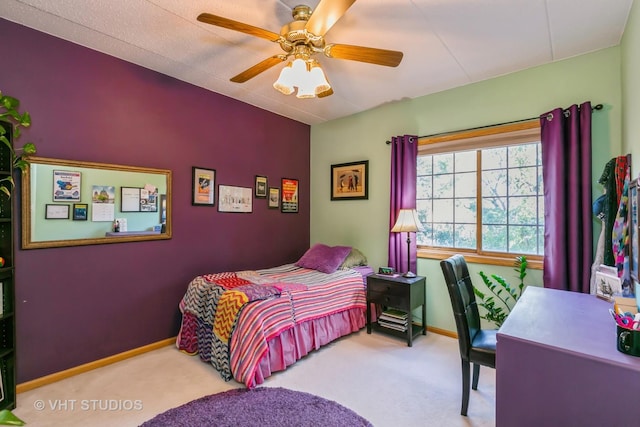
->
[0,92,36,197]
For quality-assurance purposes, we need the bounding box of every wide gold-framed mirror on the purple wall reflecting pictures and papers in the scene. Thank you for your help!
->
[22,157,172,249]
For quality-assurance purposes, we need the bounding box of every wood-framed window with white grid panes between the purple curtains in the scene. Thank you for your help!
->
[416,121,544,265]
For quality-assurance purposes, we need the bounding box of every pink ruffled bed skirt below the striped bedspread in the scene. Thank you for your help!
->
[252,308,366,386]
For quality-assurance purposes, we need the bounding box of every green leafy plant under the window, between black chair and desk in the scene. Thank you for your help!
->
[473,255,527,328]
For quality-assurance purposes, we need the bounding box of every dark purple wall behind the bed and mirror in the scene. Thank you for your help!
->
[0,19,310,383]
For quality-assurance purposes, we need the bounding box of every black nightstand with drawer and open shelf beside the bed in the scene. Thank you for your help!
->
[367,274,427,347]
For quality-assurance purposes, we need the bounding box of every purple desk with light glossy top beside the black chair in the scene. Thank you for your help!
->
[496,287,640,427]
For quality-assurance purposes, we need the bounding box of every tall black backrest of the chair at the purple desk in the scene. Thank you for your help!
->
[440,255,481,361]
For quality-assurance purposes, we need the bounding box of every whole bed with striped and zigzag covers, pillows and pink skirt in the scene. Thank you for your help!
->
[176,244,372,388]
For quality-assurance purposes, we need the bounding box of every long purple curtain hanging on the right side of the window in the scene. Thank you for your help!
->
[540,102,593,293]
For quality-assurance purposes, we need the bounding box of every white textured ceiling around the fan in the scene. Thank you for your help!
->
[0,0,633,124]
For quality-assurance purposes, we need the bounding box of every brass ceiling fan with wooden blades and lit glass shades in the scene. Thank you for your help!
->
[198,0,403,98]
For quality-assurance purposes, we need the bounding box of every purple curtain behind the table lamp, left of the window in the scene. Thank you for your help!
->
[388,135,418,273]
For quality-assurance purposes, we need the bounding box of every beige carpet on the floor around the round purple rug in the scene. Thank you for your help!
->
[13,330,495,427]
